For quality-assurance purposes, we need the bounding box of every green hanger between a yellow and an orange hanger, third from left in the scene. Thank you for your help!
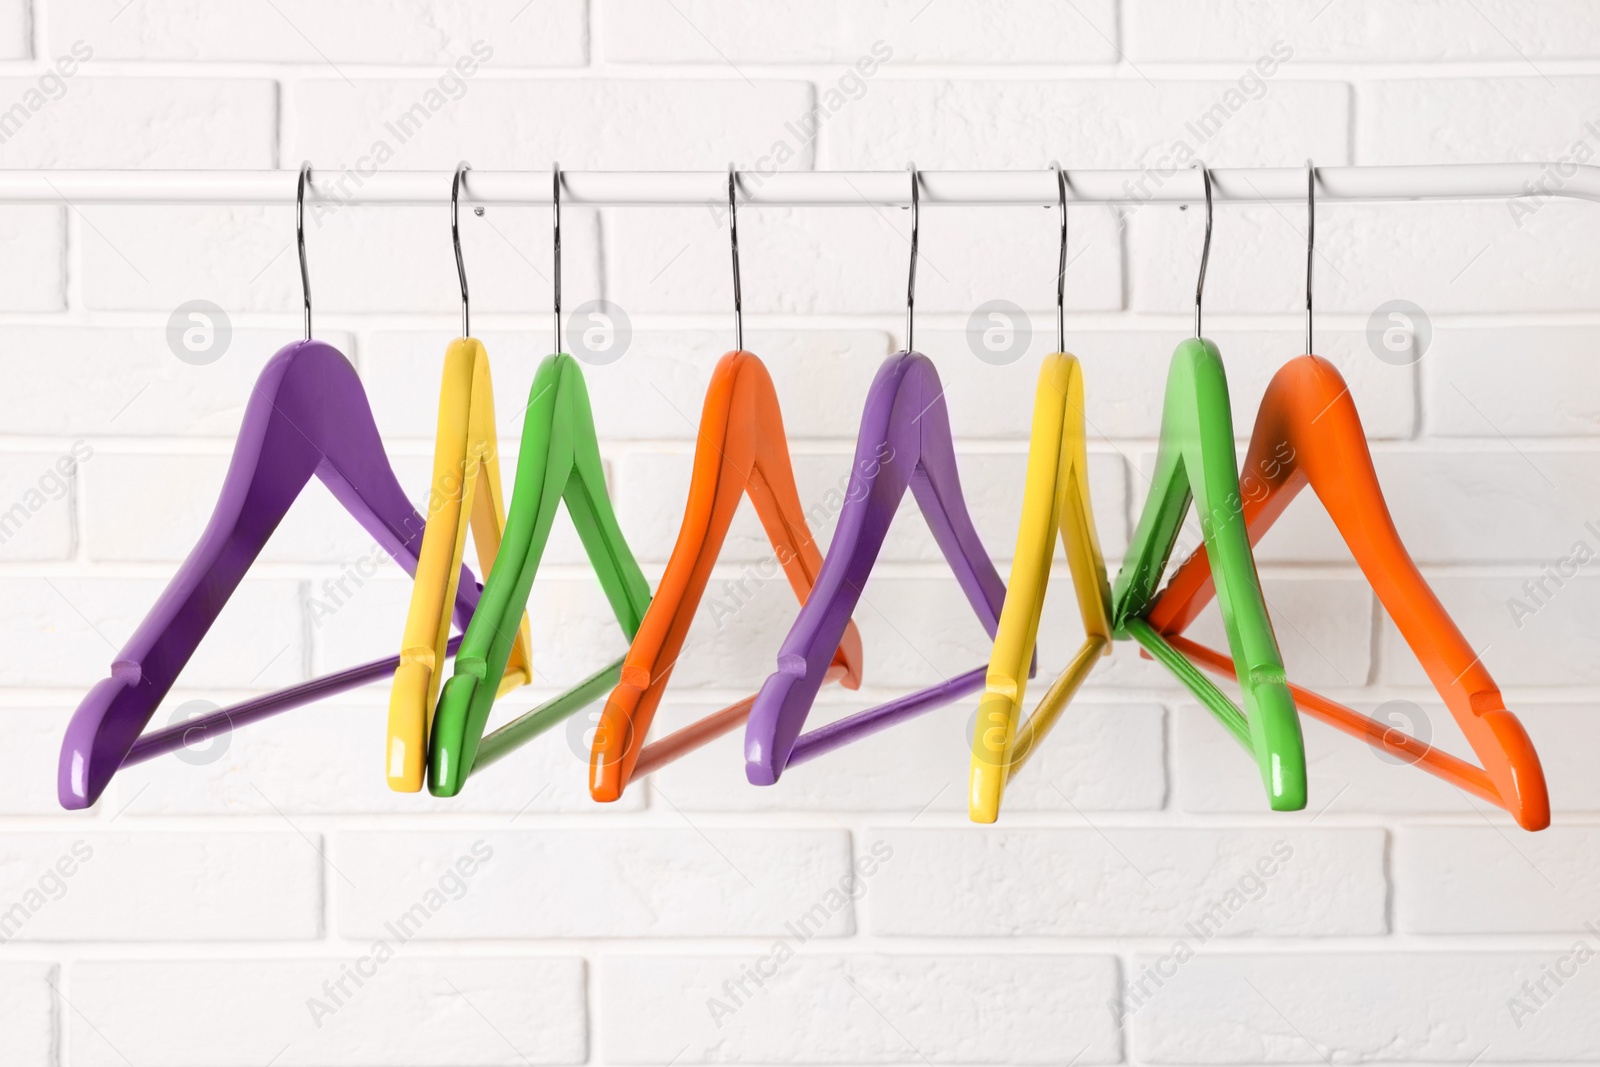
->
[427,165,650,797]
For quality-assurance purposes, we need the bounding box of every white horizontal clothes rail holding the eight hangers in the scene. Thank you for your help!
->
[0,162,1600,206]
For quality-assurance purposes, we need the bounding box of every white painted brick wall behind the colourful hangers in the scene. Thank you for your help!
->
[0,0,1600,1067]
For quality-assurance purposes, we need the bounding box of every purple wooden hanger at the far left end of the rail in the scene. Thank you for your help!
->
[58,163,478,808]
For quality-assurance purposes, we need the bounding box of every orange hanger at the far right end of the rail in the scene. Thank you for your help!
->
[1149,165,1550,830]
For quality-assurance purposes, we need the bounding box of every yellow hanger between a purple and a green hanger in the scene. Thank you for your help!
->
[966,163,1112,822]
